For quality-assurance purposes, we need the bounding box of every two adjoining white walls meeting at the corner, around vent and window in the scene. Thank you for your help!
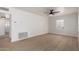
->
[10,8,78,42]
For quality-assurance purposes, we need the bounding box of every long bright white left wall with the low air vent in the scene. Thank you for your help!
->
[10,8,48,42]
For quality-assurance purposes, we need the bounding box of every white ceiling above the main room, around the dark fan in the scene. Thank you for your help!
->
[16,7,78,15]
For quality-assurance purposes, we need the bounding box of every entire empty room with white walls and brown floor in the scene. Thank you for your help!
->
[0,7,79,51]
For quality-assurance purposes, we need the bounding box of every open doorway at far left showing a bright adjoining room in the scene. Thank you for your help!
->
[0,8,10,39]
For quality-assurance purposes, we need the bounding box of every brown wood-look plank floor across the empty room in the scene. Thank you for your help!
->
[0,34,79,51]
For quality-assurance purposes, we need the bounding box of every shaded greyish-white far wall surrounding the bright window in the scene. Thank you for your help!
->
[49,13,78,37]
